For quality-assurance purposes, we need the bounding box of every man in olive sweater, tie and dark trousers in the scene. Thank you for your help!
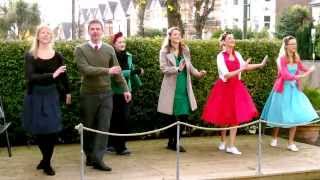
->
[75,20,131,171]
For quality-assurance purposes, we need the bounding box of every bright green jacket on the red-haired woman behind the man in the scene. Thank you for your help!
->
[111,52,142,94]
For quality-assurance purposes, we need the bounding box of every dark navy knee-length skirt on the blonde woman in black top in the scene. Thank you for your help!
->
[22,85,62,134]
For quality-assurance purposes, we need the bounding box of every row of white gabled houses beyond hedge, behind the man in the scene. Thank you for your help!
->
[56,0,137,39]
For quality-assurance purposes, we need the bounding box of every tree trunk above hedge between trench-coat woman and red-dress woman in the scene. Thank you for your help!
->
[194,0,215,39]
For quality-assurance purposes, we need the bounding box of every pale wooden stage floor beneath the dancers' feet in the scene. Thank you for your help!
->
[0,136,320,180]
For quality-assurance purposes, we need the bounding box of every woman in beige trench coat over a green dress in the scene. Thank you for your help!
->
[158,27,206,152]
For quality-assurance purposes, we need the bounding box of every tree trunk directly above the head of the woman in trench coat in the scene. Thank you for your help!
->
[167,0,184,36]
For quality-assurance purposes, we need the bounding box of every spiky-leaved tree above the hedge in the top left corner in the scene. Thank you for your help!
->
[0,0,40,40]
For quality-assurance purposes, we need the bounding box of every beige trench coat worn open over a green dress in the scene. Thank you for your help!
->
[158,47,199,115]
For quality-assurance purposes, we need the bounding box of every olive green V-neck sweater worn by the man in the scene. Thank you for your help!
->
[75,43,129,93]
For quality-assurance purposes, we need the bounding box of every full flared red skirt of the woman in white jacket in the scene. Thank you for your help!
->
[201,78,259,126]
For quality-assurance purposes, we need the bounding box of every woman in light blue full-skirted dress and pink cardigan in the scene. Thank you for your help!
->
[261,36,319,151]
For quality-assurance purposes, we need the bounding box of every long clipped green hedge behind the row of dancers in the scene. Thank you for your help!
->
[0,38,280,144]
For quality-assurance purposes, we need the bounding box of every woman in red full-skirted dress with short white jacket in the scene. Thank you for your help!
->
[202,32,267,155]
